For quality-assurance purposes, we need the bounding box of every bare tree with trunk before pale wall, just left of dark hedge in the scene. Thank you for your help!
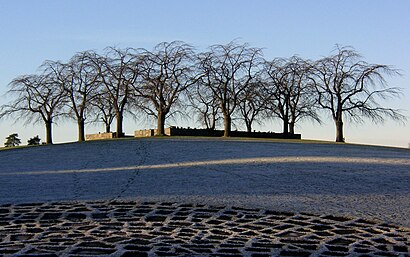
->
[134,41,195,135]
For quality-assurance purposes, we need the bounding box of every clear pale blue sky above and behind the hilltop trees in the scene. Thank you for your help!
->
[0,0,410,147]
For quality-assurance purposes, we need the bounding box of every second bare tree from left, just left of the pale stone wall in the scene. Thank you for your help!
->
[64,51,100,142]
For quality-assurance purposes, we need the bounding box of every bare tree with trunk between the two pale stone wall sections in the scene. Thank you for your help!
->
[93,47,139,137]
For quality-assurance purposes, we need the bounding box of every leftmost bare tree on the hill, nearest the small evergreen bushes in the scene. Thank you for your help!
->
[0,68,65,144]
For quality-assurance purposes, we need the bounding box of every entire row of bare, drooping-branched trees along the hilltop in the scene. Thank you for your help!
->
[0,41,406,144]
